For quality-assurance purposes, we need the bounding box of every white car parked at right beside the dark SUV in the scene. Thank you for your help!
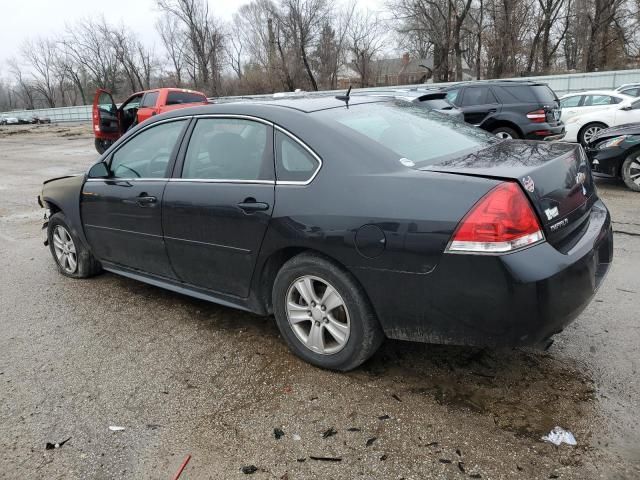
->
[563,99,640,145]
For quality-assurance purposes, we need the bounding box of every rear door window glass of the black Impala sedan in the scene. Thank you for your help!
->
[182,118,273,181]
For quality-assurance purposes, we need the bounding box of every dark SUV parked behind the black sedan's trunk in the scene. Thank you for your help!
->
[443,80,564,140]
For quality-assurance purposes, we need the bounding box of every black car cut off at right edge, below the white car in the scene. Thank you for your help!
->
[586,123,640,192]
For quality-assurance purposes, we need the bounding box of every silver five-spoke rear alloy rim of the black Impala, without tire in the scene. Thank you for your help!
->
[286,275,351,355]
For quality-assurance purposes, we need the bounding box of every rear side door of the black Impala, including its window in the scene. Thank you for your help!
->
[163,116,275,298]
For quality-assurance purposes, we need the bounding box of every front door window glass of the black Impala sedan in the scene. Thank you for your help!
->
[109,120,186,178]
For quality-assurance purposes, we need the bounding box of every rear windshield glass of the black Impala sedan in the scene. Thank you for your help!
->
[312,101,500,168]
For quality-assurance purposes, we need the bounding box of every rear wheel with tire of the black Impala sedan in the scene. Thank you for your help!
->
[273,254,384,371]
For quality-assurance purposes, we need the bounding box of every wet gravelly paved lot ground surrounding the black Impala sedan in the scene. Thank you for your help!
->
[0,125,640,480]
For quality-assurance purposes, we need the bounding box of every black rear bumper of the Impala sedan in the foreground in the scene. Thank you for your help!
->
[358,201,613,347]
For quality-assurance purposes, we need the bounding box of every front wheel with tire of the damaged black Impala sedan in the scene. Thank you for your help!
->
[47,212,102,278]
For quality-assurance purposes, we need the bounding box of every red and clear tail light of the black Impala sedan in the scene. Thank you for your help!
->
[447,182,544,253]
